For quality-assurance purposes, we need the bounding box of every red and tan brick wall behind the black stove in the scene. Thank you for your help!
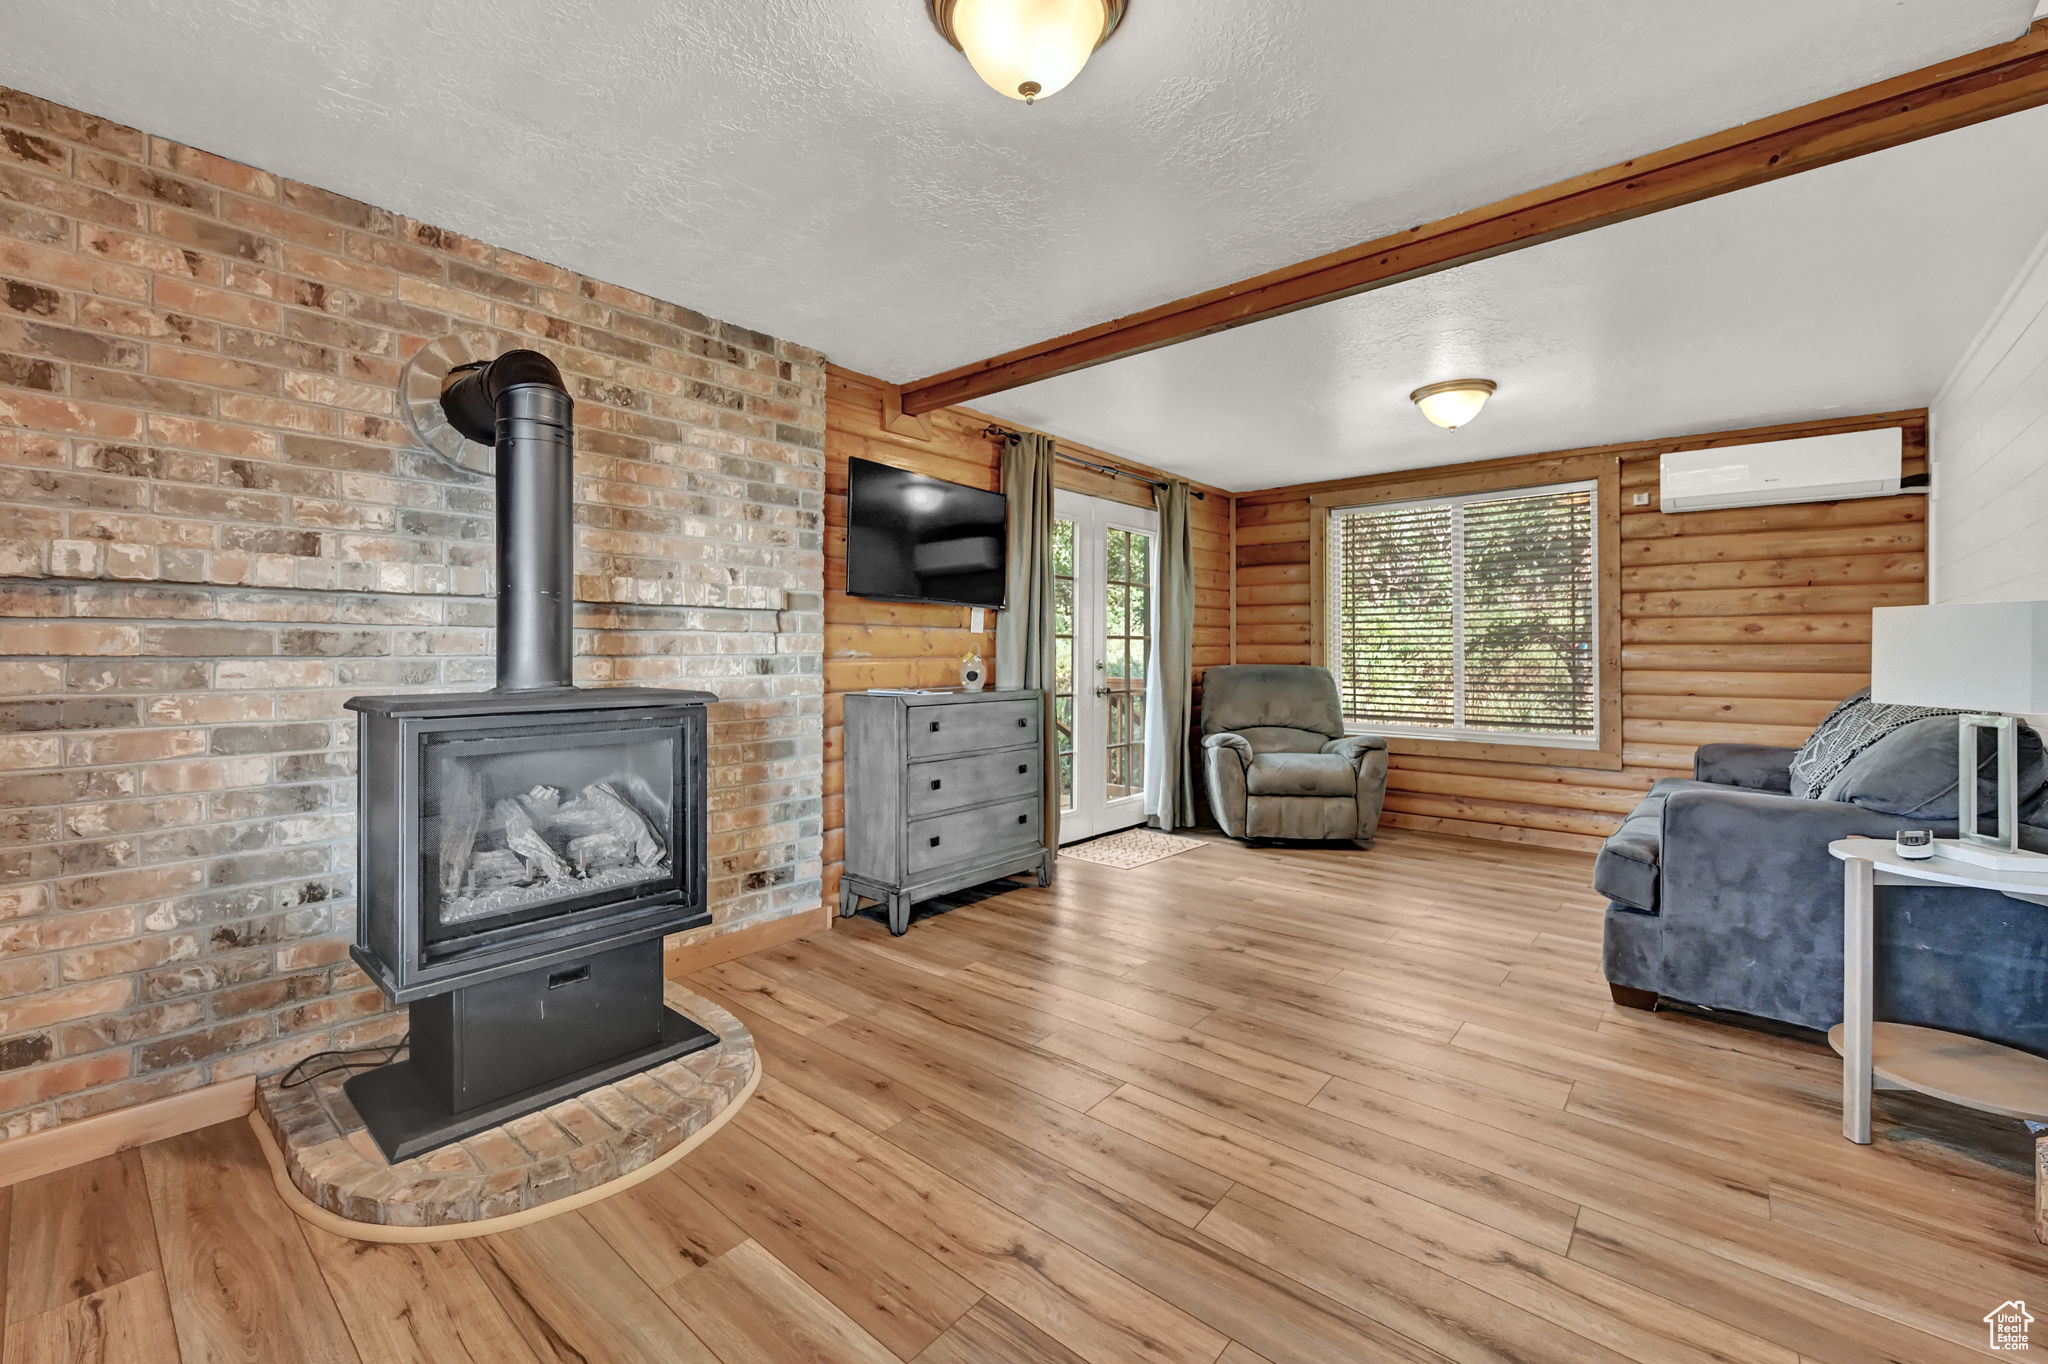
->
[0,90,823,1137]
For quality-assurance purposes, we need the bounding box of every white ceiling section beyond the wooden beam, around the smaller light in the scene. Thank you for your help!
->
[977,109,2048,489]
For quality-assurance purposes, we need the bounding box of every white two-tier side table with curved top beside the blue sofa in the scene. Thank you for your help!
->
[1827,838,2048,1145]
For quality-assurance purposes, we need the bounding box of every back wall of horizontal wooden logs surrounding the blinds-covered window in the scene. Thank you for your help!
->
[1235,410,1927,850]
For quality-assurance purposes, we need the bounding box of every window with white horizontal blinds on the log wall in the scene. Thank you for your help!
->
[1325,483,1599,745]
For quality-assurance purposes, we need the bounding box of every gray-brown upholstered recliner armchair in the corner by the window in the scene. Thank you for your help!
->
[1202,664,1386,840]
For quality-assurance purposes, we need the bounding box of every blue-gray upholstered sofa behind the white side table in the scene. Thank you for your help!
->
[1593,702,2048,1053]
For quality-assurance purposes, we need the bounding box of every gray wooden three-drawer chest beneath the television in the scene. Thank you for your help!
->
[840,690,1053,934]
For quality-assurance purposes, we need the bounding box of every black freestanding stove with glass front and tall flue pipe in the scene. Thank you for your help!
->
[346,350,717,1161]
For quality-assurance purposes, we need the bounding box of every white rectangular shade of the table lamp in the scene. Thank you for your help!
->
[1870,602,2048,715]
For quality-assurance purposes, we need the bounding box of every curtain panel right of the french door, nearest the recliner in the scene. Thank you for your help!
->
[1145,479,1196,829]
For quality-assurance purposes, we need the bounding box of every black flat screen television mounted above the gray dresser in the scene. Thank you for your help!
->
[846,459,1008,608]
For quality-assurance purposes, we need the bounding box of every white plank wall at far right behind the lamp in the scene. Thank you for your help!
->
[1929,223,2048,602]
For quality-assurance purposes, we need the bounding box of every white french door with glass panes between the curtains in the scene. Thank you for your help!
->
[1053,492,1159,844]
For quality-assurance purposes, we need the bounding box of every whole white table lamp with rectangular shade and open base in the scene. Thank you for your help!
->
[1870,602,2048,877]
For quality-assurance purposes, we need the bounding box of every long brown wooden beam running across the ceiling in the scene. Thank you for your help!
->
[899,20,2048,416]
